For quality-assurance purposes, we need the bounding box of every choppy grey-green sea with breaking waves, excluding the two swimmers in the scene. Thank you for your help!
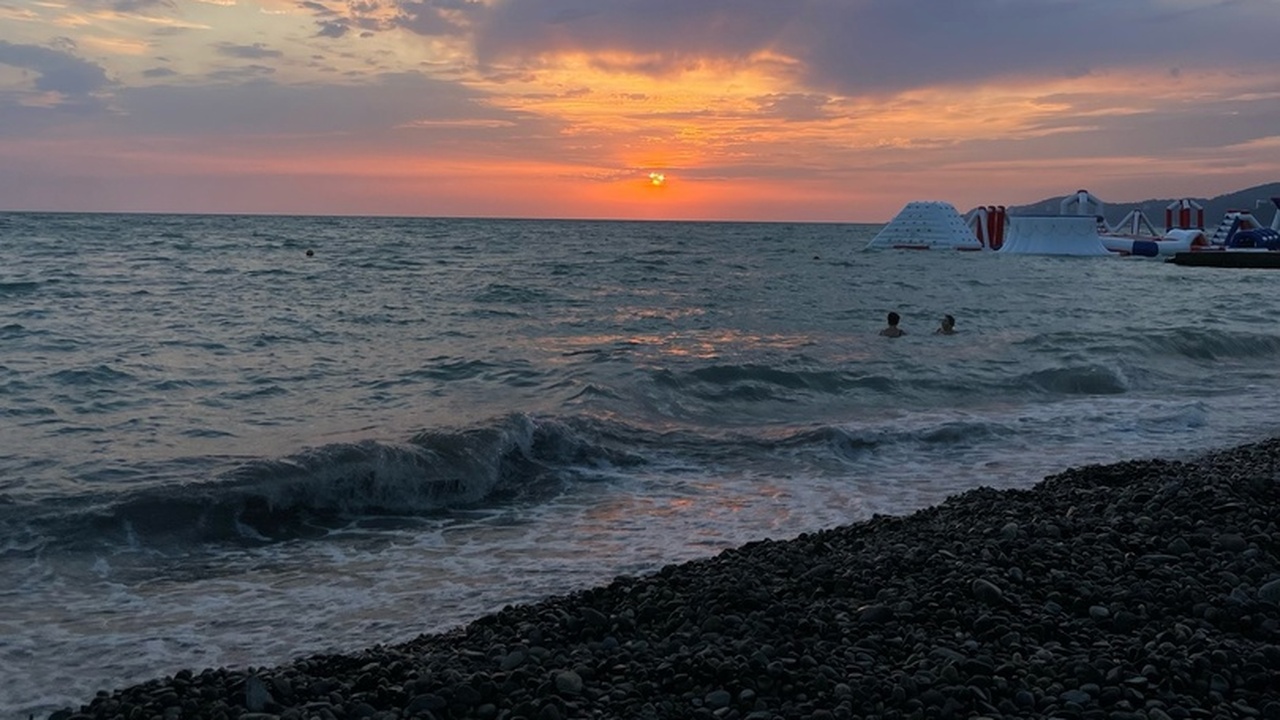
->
[0,213,1280,717]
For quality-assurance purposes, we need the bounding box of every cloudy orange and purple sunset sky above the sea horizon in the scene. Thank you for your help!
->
[0,0,1280,222]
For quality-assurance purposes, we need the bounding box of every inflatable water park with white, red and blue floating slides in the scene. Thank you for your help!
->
[867,190,1280,268]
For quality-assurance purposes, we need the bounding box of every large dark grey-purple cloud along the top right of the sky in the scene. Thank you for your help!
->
[476,0,1280,94]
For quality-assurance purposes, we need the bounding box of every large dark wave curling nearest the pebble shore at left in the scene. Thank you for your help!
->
[0,415,644,548]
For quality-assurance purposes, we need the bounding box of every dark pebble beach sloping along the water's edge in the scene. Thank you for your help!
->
[50,438,1280,720]
